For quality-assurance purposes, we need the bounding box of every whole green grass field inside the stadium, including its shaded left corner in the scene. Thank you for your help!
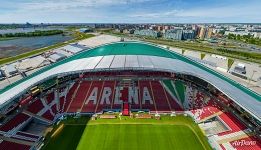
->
[43,117,211,150]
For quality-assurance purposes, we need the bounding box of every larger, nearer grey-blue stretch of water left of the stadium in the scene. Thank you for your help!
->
[0,35,73,58]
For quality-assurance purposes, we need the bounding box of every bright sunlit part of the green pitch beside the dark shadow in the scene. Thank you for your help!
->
[77,124,204,150]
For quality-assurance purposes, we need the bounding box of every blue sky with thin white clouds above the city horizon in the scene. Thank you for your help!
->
[0,0,261,23]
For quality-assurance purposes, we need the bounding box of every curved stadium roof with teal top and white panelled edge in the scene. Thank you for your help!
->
[0,41,261,120]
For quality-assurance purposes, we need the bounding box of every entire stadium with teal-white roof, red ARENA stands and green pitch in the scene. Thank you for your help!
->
[0,41,261,150]
